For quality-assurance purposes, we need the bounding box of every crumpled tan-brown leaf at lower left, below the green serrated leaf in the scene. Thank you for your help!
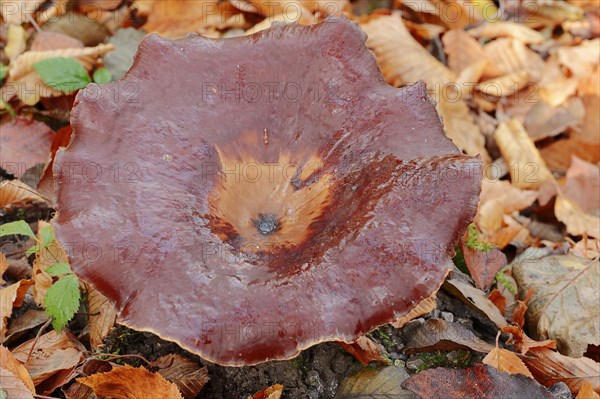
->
[12,331,86,392]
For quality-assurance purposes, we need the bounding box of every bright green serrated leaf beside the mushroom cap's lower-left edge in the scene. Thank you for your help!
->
[44,274,81,331]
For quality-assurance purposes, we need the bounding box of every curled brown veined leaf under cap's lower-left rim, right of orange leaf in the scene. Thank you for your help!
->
[152,354,209,399]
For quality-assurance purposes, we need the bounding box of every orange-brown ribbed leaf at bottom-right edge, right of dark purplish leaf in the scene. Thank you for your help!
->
[523,348,600,394]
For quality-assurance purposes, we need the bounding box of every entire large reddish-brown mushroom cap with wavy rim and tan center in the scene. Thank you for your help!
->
[53,18,482,366]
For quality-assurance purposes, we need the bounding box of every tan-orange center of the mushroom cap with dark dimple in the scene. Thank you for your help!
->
[209,149,331,253]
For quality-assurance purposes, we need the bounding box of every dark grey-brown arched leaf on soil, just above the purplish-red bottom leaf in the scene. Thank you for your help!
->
[405,319,494,354]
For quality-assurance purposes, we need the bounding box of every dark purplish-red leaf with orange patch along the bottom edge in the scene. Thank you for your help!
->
[402,364,554,399]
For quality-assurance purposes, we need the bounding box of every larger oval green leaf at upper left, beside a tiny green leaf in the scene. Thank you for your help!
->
[33,57,91,93]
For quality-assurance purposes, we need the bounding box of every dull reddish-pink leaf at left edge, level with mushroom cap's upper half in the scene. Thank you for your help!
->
[0,117,54,178]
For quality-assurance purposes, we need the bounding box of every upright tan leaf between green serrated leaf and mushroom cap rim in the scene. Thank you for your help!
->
[85,284,117,349]
